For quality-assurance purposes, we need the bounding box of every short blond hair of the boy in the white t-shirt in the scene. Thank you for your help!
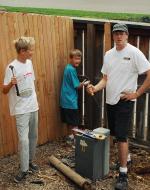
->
[14,36,35,53]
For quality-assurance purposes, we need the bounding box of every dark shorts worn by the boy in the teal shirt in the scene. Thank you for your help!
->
[61,108,79,126]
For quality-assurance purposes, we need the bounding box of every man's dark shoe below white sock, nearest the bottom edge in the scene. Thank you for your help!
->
[115,172,128,190]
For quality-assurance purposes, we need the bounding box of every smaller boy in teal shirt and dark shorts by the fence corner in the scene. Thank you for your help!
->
[60,49,84,137]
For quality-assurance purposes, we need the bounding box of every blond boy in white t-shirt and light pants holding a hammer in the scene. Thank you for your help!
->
[3,37,39,182]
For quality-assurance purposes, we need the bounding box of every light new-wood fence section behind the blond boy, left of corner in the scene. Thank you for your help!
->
[0,13,74,156]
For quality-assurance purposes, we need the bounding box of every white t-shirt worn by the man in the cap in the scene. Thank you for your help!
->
[101,43,150,105]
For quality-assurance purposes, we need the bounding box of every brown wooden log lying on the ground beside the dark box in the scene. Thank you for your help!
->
[49,155,92,190]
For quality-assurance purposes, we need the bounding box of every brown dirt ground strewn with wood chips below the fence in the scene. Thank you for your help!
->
[0,140,150,190]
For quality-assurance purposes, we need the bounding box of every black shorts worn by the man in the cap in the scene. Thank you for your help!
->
[107,100,134,142]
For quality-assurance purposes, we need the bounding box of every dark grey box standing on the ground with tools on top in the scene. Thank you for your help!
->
[75,129,109,181]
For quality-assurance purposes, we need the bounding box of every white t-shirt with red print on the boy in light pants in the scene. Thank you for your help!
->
[4,59,39,115]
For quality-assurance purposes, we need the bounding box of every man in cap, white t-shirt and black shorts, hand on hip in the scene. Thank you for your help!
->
[87,23,150,189]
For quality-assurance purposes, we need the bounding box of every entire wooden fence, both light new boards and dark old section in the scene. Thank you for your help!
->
[0,13,150,156]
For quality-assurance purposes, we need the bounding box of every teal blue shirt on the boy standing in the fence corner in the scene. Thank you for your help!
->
[60,64,80,109]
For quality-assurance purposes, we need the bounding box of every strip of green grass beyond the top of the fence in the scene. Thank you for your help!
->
[0,6,150,22]
